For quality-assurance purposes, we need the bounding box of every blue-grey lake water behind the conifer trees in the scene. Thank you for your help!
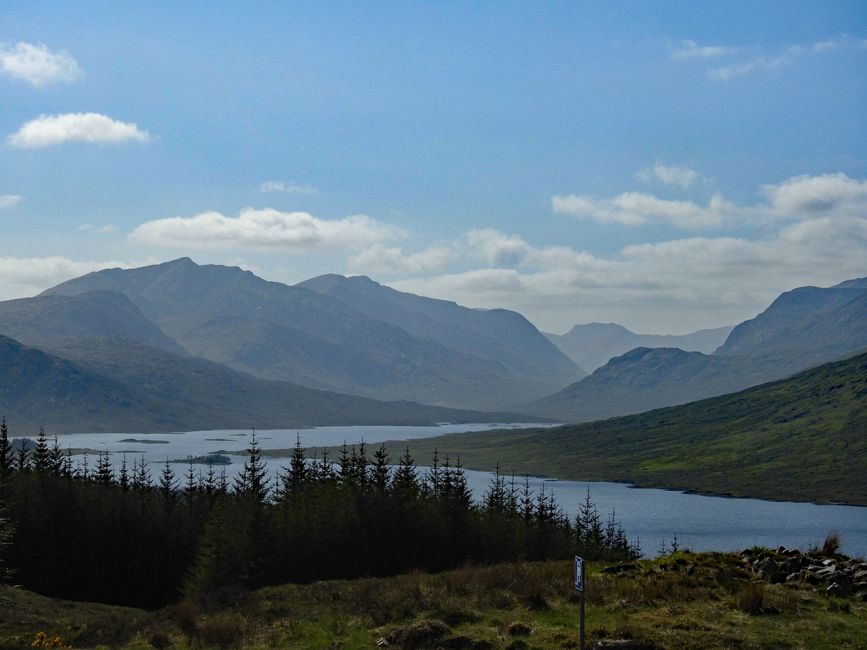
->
[40,424,867,556]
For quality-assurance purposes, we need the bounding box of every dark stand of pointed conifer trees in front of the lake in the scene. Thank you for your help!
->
[0,419,640,607]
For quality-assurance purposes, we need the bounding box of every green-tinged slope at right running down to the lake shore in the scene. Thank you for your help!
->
[384,354,867,505]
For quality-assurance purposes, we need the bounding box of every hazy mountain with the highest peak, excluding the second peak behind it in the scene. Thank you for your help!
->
[43,258,569,409]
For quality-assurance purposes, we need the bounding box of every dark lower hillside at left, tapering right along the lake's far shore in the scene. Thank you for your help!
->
[0,337,536,434]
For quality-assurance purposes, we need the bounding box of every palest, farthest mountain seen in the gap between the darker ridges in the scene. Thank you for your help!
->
[545,323,732,372]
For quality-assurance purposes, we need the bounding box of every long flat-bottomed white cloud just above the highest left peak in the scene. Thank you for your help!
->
[130,208,400,250]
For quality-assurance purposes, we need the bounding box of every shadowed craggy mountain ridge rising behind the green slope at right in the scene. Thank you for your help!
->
[521,278,867,422]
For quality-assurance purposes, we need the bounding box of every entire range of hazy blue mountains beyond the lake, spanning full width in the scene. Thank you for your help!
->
[0,258,867,431]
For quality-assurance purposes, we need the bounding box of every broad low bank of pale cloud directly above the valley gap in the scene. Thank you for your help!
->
[389,217,867,333]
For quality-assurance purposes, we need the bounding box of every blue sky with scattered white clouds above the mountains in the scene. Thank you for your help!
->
[0,0,867,333]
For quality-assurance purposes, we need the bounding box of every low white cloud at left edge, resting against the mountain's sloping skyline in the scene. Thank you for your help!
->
[0,256,130,300]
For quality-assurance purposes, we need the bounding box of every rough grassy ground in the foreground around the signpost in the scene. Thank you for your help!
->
[0,552,867,650]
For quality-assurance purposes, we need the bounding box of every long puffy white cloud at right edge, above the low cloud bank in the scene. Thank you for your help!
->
[551,173,867,229]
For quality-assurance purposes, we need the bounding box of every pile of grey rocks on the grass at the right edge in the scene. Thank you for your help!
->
[741,546,867,602]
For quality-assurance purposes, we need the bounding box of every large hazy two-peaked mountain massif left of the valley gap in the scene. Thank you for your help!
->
[37,258,585,409]
